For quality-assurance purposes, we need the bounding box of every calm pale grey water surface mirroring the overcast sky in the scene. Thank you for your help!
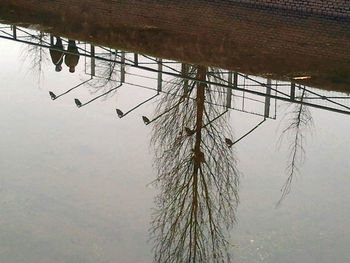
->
[0,28,350,263]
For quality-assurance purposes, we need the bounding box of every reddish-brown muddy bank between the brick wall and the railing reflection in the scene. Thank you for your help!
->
[0,0,350,92]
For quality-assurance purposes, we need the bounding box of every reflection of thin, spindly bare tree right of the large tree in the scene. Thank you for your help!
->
[277,88,313,205]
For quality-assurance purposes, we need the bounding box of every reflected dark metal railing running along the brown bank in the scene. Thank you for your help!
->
[0,22,350,119]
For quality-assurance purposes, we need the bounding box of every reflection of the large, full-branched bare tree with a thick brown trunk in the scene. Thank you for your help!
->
[151,66,239,262]
